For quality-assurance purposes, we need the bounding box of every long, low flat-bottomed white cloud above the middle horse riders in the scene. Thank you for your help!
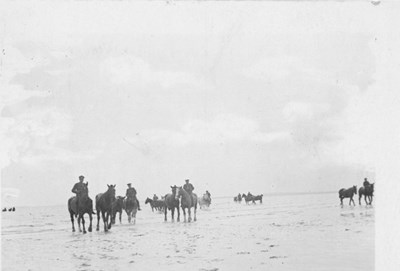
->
[126,115,289,149]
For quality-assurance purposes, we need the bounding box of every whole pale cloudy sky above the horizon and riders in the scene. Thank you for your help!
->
[0,1,395,205]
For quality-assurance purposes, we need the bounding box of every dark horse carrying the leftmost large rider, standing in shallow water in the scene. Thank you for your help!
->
[68,183,94,233]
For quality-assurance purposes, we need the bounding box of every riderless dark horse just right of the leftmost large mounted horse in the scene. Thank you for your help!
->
[96,184,115,231]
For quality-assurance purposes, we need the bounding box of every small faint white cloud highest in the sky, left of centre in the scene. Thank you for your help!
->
[100,56,203,88]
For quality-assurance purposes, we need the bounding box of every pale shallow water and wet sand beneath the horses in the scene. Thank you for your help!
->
[2,194,375,270]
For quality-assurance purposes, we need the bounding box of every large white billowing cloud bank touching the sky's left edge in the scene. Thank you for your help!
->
[0,46,99,168]
